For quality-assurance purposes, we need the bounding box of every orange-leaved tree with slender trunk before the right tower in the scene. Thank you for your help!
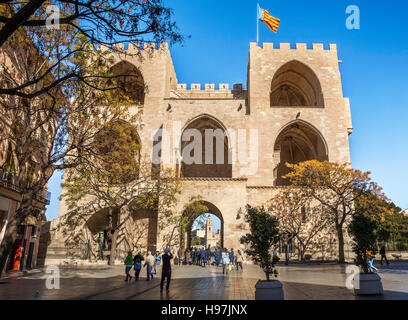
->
[285,160,387,263]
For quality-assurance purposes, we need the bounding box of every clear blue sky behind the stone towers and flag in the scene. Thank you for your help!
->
[43,0,408,219]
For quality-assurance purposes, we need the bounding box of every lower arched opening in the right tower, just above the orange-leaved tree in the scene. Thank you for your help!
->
[274,120,328,186]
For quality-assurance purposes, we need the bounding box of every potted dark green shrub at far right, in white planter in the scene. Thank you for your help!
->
[349,213,383,295]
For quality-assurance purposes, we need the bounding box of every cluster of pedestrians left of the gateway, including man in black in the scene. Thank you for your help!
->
[124,248,173,292]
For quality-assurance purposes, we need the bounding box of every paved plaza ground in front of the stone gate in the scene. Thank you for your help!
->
[0,262,408,300]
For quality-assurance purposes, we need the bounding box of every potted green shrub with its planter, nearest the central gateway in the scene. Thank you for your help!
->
[241,205,284,300]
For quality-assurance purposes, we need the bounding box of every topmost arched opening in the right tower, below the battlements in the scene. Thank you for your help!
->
[270,60,324,107]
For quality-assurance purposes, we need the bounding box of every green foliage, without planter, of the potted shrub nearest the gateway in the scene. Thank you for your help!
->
[240,205,280,281]
